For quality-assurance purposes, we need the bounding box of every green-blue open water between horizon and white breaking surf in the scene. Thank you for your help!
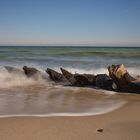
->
[0,46,140,70]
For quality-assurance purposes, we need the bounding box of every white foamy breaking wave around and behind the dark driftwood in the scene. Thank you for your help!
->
[0,67,140,88]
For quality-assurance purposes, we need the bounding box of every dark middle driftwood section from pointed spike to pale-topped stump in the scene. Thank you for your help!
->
[60,68,113,90]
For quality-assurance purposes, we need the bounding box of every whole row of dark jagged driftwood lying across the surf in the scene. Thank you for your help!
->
[5,64,140,93]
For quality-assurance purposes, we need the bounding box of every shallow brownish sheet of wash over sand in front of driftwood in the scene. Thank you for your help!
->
[0,84,125,116]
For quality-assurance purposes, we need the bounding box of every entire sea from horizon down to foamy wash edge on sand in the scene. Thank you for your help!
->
[0,46,140,117]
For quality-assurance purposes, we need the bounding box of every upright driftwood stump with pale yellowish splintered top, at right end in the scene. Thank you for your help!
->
[108,64,140,93]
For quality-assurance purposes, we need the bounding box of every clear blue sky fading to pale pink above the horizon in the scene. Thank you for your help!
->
[0,0,140,46]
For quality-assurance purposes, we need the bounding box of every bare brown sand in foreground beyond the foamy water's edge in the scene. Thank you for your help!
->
[0,94,140,140]
